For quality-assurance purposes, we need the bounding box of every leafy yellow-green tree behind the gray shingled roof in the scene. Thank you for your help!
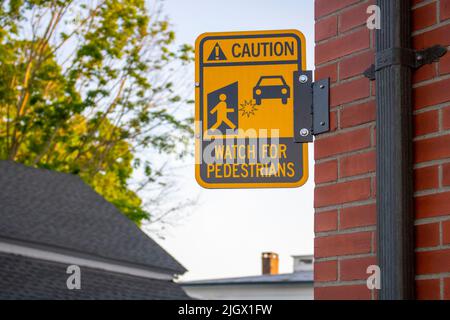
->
[0,0,192,224]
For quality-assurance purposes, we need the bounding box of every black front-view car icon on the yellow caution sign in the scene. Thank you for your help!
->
[253,76,291,105]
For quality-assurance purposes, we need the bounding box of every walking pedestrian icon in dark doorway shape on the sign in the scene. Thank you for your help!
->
[207,82,239,134]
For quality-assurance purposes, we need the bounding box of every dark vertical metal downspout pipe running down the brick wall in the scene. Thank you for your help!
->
[376,0,414,300]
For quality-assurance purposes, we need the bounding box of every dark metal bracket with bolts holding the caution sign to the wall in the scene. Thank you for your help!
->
[294,71,330,143]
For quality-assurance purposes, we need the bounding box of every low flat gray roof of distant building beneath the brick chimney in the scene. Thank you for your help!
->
[180,271,313,286]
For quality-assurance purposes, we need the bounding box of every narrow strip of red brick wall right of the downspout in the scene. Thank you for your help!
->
[412,0,450,299]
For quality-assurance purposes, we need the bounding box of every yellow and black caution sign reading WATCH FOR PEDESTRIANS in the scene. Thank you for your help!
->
[195,30,308,188]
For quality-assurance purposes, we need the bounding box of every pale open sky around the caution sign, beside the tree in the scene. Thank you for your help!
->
[155,0,314,281]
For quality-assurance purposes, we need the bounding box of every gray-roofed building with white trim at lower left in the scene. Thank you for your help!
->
[0,161,189,300]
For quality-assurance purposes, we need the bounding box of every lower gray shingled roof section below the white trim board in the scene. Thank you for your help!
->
[0,253,189,300]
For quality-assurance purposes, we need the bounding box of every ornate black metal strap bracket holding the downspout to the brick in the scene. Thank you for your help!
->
[364,45,447,81]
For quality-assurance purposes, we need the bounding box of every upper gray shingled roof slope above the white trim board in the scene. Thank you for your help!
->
[0,161,186,274]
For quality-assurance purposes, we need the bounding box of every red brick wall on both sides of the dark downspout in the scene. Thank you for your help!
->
[314,0,450,299]
